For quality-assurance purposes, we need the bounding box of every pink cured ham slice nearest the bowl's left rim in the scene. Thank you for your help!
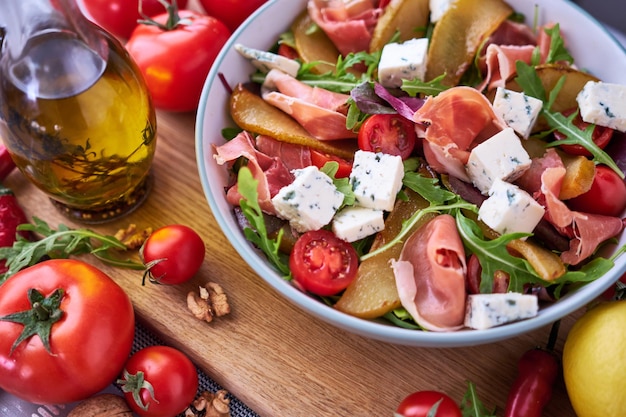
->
[213,132,294,214]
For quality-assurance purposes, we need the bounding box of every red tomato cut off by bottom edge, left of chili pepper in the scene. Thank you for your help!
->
[396,391,462,417]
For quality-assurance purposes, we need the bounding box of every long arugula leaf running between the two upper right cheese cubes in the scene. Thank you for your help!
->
[515,61,624,179]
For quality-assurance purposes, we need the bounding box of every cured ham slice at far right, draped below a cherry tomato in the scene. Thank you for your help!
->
[541,167,624,265]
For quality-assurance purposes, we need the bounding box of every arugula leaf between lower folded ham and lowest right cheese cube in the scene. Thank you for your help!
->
[456,212,546,293]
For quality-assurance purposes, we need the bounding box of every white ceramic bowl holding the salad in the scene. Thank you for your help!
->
[196,0,626,347]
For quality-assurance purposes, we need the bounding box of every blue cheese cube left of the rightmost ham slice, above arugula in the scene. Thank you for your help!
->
[478,180,545,234]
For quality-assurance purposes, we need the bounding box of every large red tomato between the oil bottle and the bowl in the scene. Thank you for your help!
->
[126,10,230,111]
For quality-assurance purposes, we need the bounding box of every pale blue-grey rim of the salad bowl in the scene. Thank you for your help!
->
[195,0,626,347]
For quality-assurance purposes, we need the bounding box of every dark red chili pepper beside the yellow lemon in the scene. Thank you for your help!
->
[504,321,560,417]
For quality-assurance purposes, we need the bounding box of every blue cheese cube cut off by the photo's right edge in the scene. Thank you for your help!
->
[576,81,626,132]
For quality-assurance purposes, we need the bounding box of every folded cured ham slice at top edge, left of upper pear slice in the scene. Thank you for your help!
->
[307,0,382,56]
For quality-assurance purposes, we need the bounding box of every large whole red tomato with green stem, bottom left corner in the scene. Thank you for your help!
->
[0,259,135,404]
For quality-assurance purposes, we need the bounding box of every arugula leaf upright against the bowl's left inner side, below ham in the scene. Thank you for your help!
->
[237,167,291,279]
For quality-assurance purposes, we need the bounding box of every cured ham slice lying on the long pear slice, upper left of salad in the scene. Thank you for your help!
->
[262,70,357,140]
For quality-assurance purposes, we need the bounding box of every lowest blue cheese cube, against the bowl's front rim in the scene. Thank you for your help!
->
[465,292,539,330]
